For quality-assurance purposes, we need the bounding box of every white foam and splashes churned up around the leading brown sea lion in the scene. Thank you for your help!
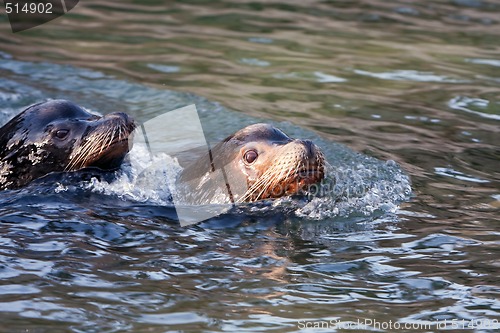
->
[88,139,411,220]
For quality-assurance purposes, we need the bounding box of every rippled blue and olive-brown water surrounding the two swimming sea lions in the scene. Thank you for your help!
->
[0,0,500,332]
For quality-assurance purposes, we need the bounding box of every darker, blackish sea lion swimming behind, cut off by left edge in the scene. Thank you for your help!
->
[0,100,135,189]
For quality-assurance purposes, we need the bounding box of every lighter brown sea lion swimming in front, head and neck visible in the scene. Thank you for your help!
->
[178,124,325,203]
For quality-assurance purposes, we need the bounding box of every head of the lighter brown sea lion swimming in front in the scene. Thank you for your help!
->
[230,124,325,201]
